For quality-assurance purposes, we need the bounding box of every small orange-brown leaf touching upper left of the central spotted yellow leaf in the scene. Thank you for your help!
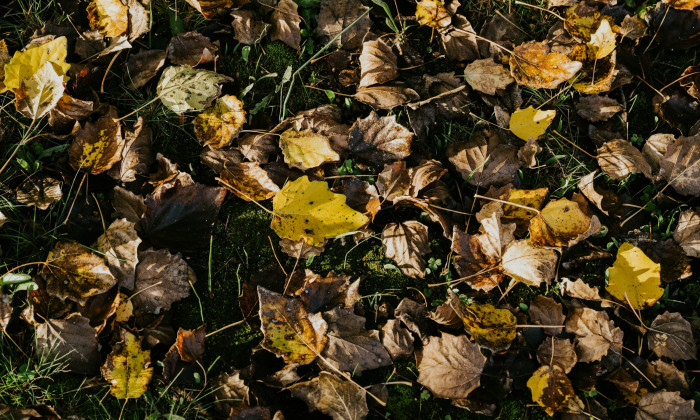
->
[221,162,280,201]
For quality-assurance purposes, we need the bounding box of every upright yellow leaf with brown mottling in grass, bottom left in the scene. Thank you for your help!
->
[101,330,153,400]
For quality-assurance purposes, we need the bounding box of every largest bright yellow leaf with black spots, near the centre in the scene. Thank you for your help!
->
[271,176,369,245]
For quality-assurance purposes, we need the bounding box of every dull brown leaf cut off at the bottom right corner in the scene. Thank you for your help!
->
[634,390,700,420]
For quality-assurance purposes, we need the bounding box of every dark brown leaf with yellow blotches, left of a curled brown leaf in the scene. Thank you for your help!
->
[68,105,124,175]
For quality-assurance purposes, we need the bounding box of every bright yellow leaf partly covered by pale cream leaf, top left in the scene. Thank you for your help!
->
[0,36,70,93]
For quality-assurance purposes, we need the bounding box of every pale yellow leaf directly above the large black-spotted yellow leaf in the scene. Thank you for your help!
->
[280,128,340,171]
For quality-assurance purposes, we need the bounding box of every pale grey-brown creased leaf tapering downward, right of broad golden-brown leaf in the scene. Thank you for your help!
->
[95,219,141,290]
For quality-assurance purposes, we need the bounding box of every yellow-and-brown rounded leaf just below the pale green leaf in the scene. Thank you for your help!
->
[193,95,246,149]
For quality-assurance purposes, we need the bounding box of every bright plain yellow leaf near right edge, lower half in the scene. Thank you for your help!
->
[605,242,664,309]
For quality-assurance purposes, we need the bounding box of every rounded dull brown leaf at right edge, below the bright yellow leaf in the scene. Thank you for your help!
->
[647,311,697,361]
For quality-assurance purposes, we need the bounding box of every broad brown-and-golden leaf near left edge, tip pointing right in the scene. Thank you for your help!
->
[40,242,117,304]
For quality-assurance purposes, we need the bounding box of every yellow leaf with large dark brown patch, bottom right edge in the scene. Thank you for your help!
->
[527,365,575,416]
